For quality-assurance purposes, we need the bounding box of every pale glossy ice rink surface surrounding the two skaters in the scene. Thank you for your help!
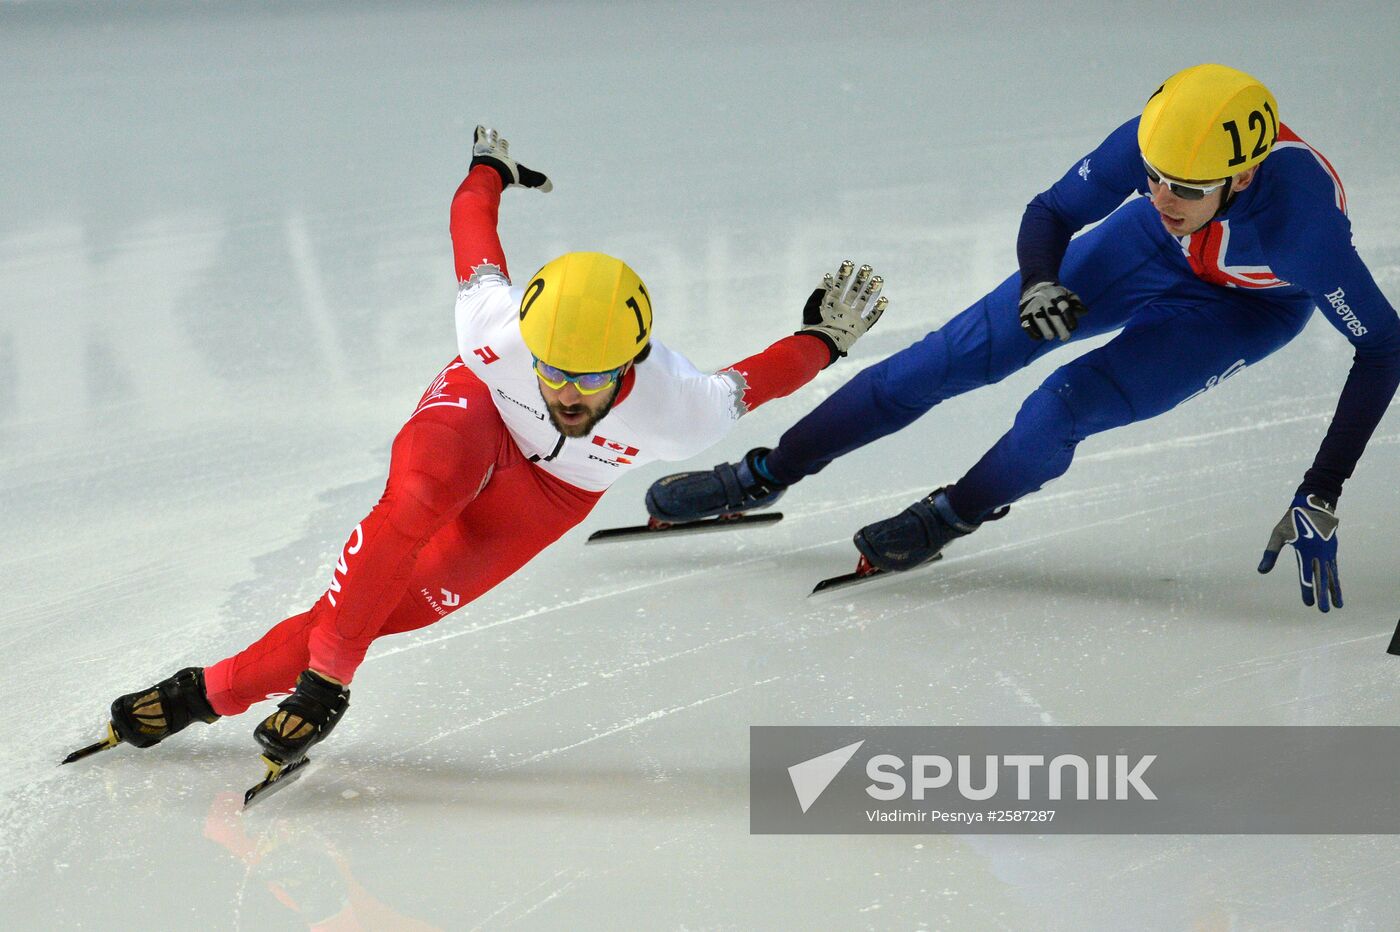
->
[0,0,1400,929]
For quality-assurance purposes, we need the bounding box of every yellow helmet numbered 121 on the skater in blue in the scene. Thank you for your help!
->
[1138,64,1278,182]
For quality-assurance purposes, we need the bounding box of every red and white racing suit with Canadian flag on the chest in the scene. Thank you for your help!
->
[204,167,832,715]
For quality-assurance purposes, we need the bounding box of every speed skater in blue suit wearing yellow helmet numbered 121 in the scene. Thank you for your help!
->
[647,64,1400,612]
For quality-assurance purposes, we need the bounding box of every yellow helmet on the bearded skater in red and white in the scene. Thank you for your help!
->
[521,252,651,372]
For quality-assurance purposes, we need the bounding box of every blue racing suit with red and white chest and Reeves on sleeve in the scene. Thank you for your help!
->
[766,118,1400,522]
